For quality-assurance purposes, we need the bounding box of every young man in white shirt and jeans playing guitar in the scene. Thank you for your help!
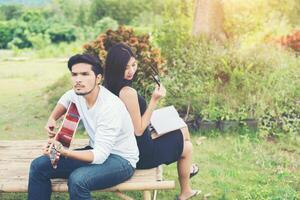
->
[28,54,138,200]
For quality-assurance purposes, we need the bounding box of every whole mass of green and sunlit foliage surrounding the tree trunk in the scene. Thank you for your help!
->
[150,0,300,135]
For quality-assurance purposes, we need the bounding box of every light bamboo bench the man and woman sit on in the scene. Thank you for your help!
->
[0,139,175,200]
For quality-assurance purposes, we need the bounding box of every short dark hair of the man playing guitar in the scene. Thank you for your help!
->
[68,53,103,76]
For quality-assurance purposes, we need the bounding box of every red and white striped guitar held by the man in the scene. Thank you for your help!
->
[50,102,80,168]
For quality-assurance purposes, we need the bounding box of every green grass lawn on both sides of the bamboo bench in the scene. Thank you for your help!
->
[0,60,300,200]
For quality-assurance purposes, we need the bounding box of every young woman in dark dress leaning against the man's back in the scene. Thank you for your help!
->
[104,43,200,199]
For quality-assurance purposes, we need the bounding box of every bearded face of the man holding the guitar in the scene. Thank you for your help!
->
[71,63,99,95]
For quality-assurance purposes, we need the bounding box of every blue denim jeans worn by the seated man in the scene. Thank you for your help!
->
[28,154,134,200]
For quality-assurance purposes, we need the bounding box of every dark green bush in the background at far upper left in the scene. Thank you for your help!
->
[0,10,80,49]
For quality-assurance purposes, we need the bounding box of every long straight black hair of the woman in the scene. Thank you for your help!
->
[104,43,135,96]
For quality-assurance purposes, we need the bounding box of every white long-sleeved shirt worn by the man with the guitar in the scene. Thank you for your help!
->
[58,86,139,168]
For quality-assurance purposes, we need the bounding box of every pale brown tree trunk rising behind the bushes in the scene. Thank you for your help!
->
[192,0,226,41]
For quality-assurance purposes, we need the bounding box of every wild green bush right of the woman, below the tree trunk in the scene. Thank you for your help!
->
[164,38,300,135]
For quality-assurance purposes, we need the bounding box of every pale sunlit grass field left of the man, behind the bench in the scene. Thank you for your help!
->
[0,60,68,139]
